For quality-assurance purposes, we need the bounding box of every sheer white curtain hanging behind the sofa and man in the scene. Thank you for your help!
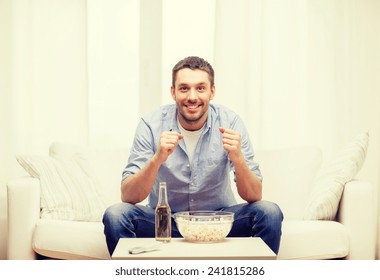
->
[0,0,380,255]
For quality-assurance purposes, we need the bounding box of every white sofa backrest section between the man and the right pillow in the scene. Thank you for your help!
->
[255,147,322,219]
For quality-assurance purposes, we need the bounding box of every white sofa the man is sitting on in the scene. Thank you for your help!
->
[7,139,376,259]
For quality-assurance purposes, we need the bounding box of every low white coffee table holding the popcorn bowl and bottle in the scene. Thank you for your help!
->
[112,237,276,260]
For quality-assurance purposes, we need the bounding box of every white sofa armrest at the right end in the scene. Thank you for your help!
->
[337,180,377,260]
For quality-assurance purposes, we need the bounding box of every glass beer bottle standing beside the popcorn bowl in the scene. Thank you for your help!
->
[155,182,172,243]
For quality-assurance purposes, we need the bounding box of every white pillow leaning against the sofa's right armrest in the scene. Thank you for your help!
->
[304,132,369,220]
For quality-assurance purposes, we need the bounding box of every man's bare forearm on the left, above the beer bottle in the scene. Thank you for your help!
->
[121,156,161,204]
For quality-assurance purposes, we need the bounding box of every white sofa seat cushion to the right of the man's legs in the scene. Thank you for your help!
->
[278,220,350,260]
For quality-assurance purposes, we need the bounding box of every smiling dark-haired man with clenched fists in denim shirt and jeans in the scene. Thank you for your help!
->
[103,57,283,254]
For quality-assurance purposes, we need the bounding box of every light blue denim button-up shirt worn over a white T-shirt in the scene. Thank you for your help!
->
[122,104,262,212]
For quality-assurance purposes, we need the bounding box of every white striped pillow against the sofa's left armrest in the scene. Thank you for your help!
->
[16,155,105,221]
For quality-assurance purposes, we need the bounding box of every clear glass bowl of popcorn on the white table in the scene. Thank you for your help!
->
[174,211,234,243]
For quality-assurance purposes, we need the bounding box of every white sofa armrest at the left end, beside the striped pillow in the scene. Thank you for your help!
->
[7,177,41,260]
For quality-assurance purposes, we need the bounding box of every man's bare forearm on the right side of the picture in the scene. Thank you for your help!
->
[234,159,262,202]
